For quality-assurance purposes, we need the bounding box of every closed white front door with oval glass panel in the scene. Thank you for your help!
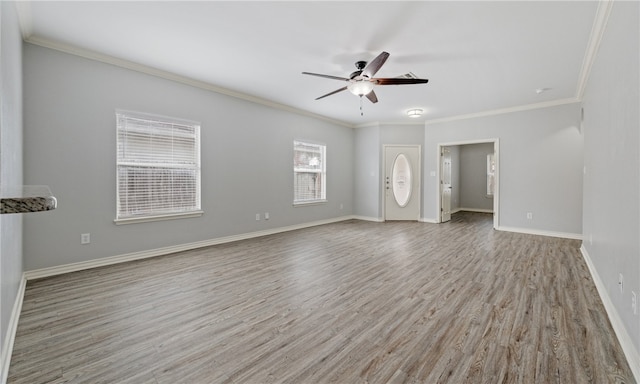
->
[384,145,420,220]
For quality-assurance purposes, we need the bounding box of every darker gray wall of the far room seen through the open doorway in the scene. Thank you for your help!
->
[459,143,493,211]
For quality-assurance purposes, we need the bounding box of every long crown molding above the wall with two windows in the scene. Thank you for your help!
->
[23,32,354,128]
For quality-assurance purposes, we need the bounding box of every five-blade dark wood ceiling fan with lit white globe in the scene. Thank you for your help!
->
[302,52,429,103]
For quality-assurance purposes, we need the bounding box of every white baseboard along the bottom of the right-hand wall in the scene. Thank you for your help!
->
[580,244,640,383]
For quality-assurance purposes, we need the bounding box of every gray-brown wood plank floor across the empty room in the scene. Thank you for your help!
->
[9,213,635,384]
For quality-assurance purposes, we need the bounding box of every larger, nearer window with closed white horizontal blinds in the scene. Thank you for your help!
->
[115,111,202,224]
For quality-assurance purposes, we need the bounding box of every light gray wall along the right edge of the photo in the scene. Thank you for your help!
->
[583,1,640,356]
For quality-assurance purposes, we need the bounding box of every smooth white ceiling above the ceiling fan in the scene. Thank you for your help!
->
[18,1,598,126]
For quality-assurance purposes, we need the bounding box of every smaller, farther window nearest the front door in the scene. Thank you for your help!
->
[293,141,327,204]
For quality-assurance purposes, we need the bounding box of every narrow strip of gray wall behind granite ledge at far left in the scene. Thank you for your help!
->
[0,1,23,366]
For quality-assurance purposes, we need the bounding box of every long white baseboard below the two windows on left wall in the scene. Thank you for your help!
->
[24,215,356,280]
